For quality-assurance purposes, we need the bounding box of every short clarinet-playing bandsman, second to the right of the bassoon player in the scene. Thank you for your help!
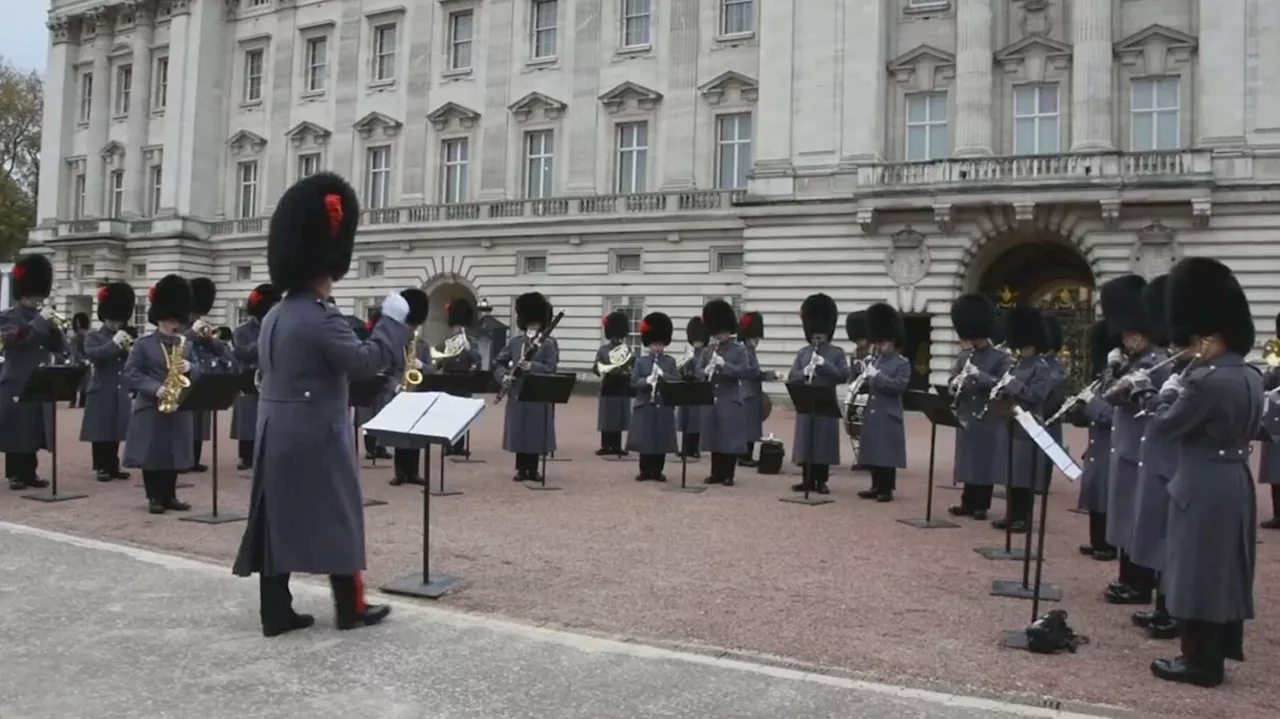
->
[627,312,676,482]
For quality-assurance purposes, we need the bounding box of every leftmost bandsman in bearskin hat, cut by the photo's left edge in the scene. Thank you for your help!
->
[0,255,67,490]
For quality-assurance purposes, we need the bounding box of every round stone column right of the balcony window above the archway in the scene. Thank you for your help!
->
[1071,0,1115,152]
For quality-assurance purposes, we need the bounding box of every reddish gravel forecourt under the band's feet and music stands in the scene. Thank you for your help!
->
[0,398,1280,718]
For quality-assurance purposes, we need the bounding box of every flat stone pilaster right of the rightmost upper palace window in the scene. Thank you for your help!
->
[1181,0,1244,147]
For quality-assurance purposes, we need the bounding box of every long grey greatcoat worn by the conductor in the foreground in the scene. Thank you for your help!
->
[234,292,410,576]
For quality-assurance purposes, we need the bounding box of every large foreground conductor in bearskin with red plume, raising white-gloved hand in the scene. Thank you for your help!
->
[234,173,426,637]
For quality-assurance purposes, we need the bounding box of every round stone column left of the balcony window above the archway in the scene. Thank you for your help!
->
[955,0,995,157]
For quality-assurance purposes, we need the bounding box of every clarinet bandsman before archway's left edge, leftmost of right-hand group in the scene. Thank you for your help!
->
[947,293,1014,521]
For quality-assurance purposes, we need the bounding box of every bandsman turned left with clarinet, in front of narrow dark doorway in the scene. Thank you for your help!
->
[852,302,911,502]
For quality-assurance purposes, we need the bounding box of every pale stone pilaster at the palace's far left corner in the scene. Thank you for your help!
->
[36,18,76,226]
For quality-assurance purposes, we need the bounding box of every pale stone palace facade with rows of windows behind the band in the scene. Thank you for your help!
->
[24,0,1280,383]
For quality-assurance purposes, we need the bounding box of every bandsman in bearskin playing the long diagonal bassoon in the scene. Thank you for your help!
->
[493,292,559,482]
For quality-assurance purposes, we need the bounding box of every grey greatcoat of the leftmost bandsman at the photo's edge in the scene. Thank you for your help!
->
[0,304,67,454]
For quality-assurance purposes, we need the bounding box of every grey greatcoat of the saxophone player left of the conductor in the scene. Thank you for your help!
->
[122,331,201,472]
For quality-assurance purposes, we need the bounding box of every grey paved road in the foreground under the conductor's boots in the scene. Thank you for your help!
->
[0,522,1111,719]
